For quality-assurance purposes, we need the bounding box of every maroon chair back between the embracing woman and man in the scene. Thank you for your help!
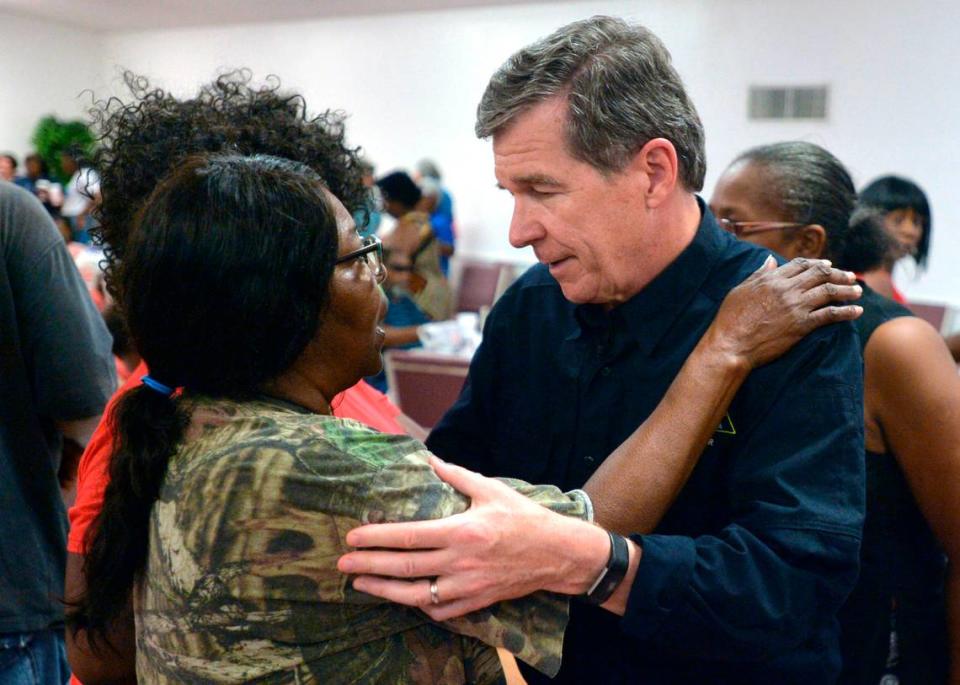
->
[384,349,470,429]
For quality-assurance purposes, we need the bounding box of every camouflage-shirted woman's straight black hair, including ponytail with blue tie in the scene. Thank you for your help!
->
[69,155,339,642]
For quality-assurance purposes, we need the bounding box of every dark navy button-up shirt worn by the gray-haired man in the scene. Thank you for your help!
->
[427,203,864,685]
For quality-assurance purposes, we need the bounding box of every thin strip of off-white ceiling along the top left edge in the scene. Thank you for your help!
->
[0,0,556,32]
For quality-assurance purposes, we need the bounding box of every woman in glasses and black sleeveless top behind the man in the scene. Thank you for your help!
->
[710,142,960,685]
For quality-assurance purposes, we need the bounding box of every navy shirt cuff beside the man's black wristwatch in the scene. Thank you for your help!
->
[621,535,697,640]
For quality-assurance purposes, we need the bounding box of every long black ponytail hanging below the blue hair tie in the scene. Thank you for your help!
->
[67,385,187,647]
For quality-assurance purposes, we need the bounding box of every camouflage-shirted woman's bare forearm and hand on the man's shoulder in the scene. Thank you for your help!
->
[584,259,860,534]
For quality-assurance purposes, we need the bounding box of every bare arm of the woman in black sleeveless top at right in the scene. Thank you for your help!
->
[864,317,960,685]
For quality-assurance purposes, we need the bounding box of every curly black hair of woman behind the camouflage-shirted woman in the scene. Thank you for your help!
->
[90,69,369,304]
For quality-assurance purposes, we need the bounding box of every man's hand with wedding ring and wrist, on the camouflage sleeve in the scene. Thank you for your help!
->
[339,457,639,621]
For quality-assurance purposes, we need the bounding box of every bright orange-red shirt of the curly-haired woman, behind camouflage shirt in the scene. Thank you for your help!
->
[67,362,404,554]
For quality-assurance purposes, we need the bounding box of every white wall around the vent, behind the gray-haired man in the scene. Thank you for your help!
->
[50,0,960,303]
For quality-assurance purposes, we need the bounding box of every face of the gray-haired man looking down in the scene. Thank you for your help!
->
[493,98,658,304]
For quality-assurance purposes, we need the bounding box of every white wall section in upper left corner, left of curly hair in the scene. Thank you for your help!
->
[0,13,102,166]
